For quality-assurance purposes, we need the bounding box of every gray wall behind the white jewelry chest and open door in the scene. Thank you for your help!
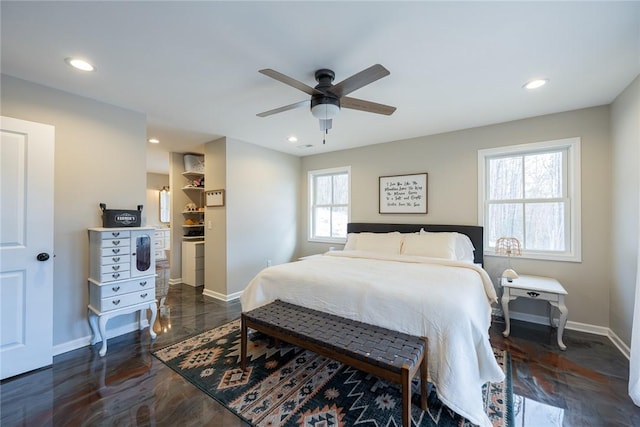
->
[0,75,146,354]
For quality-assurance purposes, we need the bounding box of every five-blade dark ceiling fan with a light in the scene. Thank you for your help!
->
[256,64,396,133]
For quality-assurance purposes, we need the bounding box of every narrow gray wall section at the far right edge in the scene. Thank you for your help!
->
[610,76,640,345]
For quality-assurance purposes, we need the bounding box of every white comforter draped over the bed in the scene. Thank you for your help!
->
[240,251,504,426]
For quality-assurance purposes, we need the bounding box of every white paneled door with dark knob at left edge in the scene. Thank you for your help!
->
[0,117,54,379]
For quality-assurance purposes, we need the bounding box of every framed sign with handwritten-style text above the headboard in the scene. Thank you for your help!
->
[380,173,427,214]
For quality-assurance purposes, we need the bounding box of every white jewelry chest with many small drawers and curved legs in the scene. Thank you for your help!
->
[88,227,157,356]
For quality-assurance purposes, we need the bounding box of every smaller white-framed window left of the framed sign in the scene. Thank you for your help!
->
[309,166,351,243]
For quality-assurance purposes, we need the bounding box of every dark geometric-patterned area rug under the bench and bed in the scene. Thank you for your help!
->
[154,320,513,427]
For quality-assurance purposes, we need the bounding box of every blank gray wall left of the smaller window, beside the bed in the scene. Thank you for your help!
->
[227,140,300,294]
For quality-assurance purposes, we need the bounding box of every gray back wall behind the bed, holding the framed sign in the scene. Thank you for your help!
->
[299,106,611,327]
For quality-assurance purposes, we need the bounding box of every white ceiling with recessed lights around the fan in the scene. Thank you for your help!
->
[0,0,640,172]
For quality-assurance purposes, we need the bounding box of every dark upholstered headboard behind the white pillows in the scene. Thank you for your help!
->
[347,222,484,265]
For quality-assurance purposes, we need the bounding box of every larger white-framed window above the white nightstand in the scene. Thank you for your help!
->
[478,138,581,262]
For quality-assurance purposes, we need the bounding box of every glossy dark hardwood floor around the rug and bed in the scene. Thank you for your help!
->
[0,272,640,427]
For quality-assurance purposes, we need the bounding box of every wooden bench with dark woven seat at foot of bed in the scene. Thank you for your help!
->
[241,300,428,427]
